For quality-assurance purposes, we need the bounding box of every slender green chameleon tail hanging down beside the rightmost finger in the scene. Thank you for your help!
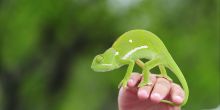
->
[168,58,189,106]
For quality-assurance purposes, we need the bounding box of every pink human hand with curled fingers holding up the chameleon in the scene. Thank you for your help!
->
[118,73,184,110]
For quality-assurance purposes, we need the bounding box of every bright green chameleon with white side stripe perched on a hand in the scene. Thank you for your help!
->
[91,29,189,106]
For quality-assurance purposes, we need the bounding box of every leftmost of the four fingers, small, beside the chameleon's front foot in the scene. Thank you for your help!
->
[127,73,141,88]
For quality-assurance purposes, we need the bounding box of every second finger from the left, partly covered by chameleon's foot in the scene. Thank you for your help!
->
[137,75,156,100]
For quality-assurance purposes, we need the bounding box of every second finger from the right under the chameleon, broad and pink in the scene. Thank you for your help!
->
[150,78,171,103]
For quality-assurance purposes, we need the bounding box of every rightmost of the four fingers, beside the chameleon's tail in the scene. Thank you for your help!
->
[171,83,185,104]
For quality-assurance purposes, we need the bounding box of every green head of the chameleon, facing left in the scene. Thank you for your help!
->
[91,48,118,72]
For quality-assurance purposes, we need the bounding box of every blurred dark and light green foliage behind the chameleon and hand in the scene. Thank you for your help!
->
[0,0,220,110]
